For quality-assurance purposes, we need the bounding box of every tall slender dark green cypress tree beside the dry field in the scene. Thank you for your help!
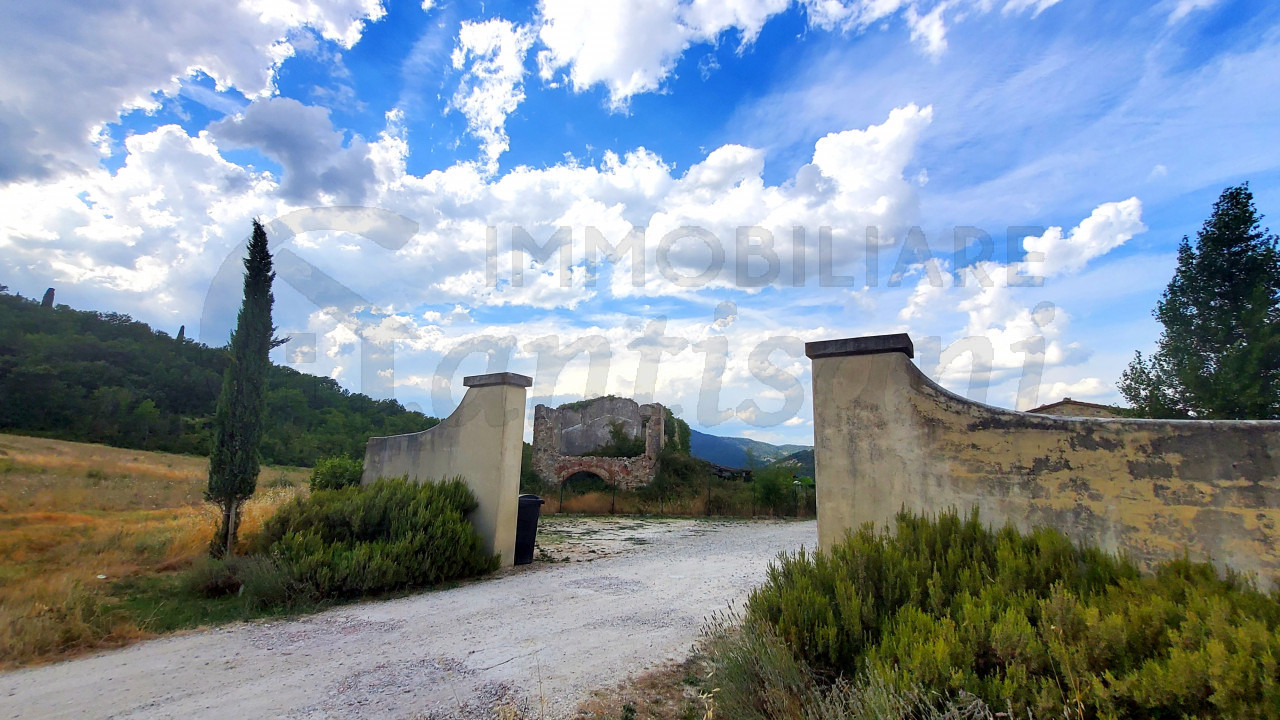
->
[205,220,275,556]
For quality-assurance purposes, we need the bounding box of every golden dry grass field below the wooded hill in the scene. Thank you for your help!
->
[0,434,308,667]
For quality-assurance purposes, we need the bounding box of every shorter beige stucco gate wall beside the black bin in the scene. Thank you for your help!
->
[364,373,532,565]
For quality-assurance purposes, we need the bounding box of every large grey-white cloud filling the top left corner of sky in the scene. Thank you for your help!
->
[0,0,383,182]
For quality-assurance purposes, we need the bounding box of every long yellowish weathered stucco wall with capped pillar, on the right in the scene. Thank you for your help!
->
[805,334,1280,587]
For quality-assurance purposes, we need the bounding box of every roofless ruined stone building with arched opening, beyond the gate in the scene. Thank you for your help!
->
[534,396,667,489]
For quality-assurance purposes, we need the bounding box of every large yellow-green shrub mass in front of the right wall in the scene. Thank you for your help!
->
[746,514,1280,717]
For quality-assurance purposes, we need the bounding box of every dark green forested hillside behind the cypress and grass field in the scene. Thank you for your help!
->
[0,293,439,465]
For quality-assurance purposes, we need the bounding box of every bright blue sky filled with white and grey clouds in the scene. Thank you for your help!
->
[0,0,1280,443]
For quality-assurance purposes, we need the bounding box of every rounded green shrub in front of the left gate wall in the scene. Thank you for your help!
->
[262,478,498,597]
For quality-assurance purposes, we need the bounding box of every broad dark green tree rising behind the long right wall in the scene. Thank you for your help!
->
[1119,183,1280,419]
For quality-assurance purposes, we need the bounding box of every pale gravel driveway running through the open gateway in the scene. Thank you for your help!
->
[0,518,817,720]
